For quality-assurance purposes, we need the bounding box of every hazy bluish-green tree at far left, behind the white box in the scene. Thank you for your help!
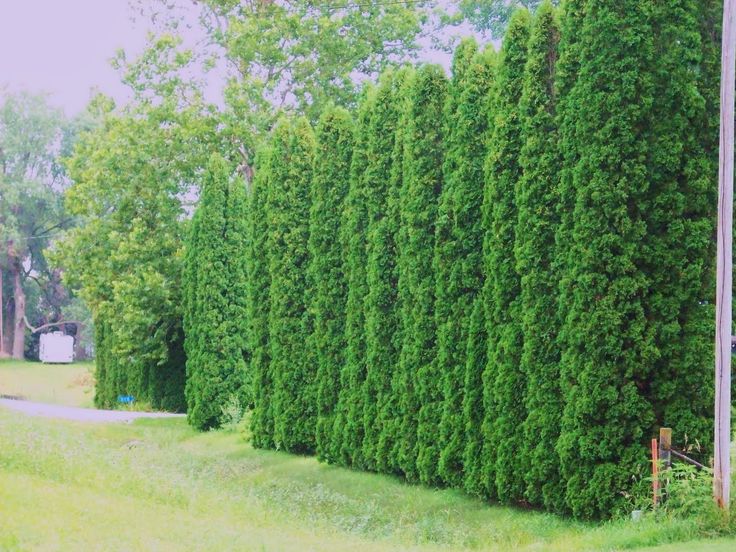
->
[0,92,86,358]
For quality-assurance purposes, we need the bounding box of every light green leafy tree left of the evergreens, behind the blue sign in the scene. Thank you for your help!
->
[60,37,228,411]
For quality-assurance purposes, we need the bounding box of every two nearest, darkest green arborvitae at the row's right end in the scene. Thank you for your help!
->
[557,0,713,517]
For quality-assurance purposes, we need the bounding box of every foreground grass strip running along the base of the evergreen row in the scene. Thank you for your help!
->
[0,410,736,552]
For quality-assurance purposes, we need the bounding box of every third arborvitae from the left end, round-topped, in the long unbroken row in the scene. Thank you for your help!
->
[309,107,353,462]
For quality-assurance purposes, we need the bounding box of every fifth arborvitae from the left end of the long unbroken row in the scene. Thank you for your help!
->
[363,71,414,470]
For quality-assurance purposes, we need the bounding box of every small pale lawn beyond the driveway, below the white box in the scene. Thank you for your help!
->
[0,360,94,407]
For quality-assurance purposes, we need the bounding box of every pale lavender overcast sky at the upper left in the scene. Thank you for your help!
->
[0,0,468,116]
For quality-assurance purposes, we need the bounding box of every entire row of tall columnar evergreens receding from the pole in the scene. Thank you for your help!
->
[180,0,718,518]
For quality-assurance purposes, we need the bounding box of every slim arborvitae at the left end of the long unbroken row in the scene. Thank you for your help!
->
[252,149,275,448]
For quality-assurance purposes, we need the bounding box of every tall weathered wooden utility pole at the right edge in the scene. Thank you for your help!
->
[713,0,736,508]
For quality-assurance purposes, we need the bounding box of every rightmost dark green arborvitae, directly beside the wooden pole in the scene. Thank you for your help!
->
[639,0,718,461]
